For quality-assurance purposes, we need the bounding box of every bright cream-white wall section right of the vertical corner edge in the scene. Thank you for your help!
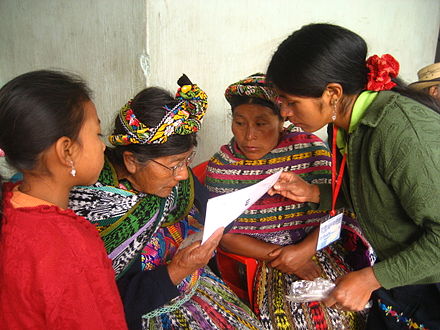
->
[147,0,440,163]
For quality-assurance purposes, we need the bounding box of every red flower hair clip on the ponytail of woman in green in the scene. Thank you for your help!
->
[366,54,400,92]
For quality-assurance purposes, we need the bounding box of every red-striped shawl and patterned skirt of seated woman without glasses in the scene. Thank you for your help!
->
[206,126,374,330]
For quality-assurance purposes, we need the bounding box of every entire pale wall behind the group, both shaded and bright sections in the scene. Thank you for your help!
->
[0,0,440,173]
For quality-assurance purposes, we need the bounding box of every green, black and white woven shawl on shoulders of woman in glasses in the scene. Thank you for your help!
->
[69,160,194,278]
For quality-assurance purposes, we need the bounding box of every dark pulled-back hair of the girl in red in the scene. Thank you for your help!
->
[0,70,91,218]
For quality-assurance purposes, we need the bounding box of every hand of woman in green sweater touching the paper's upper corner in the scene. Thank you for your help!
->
[268,172,319,203]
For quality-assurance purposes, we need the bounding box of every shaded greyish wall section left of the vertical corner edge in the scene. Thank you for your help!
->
[0,0,146,175]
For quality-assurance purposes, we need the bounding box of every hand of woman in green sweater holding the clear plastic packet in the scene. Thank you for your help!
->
[323,267,381,311]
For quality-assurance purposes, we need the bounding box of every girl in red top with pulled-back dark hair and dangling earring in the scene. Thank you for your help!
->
[0,71,126,329]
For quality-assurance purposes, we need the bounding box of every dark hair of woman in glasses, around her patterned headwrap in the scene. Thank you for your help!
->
[106,87,197,168]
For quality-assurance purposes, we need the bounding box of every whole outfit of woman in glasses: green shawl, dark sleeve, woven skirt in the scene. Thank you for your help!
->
[70,161,260,329]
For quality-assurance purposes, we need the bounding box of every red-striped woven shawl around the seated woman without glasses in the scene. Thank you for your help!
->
[206,126,331,245]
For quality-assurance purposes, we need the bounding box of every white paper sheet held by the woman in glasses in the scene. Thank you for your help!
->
[202,171,282,244]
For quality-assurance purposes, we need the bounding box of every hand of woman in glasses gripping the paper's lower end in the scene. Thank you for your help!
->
[167,228,224,285]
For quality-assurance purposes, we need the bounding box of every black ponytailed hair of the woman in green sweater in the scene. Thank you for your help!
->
[267,23,438,111]
